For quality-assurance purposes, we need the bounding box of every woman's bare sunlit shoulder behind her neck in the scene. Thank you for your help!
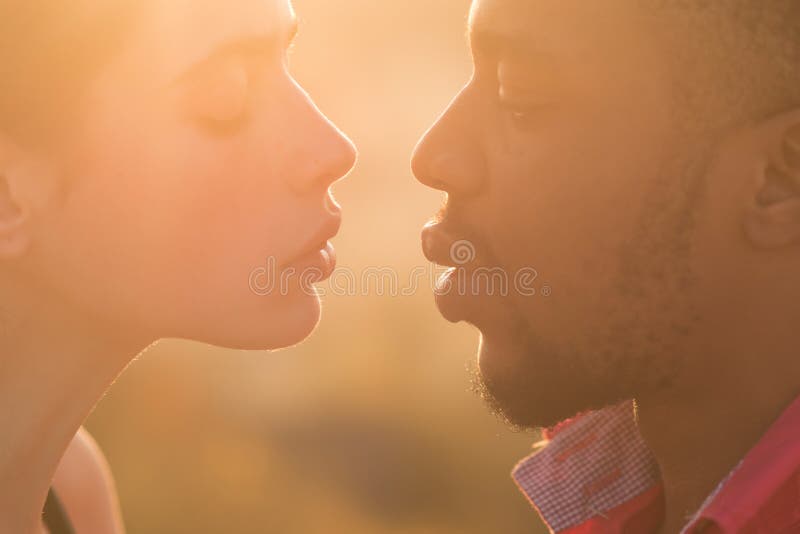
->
[53,428,124,534]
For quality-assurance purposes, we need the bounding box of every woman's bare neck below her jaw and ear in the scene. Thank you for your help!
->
[0,282,147,534]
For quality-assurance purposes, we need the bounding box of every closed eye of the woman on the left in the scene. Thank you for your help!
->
[182,57,251,137]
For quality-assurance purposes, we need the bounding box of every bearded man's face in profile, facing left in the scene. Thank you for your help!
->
[413,0,730,426]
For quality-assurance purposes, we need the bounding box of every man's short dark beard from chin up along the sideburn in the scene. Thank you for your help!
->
[472,141,709,429]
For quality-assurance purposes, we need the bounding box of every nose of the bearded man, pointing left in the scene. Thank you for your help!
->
[411,89,486,196]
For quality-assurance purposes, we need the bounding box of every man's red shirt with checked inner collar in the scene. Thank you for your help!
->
[513,398,800,534]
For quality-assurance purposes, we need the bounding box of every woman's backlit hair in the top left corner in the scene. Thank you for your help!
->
[0,0,146,143]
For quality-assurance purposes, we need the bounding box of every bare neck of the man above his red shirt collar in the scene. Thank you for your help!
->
[637,358,800,533]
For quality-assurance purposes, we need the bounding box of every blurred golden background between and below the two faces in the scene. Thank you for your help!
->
[87,0,544,534]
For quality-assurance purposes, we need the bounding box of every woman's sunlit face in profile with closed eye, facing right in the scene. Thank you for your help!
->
[33,0,355,349]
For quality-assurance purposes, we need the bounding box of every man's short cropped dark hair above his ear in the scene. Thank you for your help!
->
[639,0,800,126]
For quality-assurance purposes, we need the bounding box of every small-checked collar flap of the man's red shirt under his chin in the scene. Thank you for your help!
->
[512,402,661,532]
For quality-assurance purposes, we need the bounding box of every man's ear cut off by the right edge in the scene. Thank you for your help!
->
[744,111,800,249]
